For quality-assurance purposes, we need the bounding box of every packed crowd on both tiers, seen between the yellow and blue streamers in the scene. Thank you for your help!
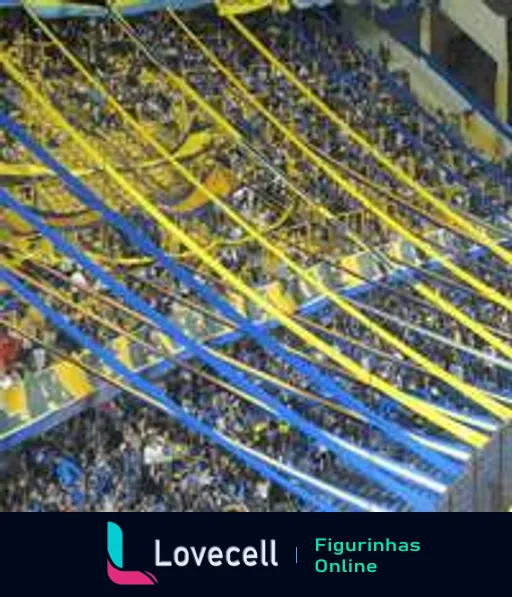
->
[0,5,512,511]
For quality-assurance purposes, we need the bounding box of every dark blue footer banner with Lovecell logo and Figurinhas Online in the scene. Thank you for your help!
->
[0,514,512,597]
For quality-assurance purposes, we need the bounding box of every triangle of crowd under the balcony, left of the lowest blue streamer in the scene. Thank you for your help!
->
[0,398,300,512]
